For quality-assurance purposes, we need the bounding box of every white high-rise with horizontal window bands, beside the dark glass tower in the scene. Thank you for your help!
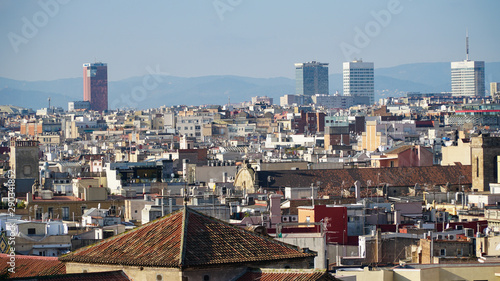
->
[343,60,375,104]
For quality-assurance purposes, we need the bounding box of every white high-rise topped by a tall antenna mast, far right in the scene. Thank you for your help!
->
[451,31,484,97]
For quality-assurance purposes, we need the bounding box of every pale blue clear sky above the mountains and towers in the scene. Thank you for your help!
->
[0,0,500,81]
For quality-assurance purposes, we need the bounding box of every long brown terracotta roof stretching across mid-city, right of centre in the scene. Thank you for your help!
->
[256,165,472,188]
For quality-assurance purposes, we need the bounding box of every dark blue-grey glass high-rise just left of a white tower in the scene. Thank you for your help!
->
[295,61,328,96]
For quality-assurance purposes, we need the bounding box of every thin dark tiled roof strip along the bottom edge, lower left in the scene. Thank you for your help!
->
[7,270,130,281]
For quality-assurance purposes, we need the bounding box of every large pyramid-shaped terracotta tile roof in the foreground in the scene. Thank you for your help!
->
[59,208,316,268]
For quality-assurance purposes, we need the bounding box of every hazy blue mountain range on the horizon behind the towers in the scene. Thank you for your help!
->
[0,62,500,109]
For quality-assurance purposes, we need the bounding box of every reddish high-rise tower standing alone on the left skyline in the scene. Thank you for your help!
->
[83,62,108,111]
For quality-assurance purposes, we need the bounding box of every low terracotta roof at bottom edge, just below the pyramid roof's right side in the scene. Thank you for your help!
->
[236,269,338,281]
